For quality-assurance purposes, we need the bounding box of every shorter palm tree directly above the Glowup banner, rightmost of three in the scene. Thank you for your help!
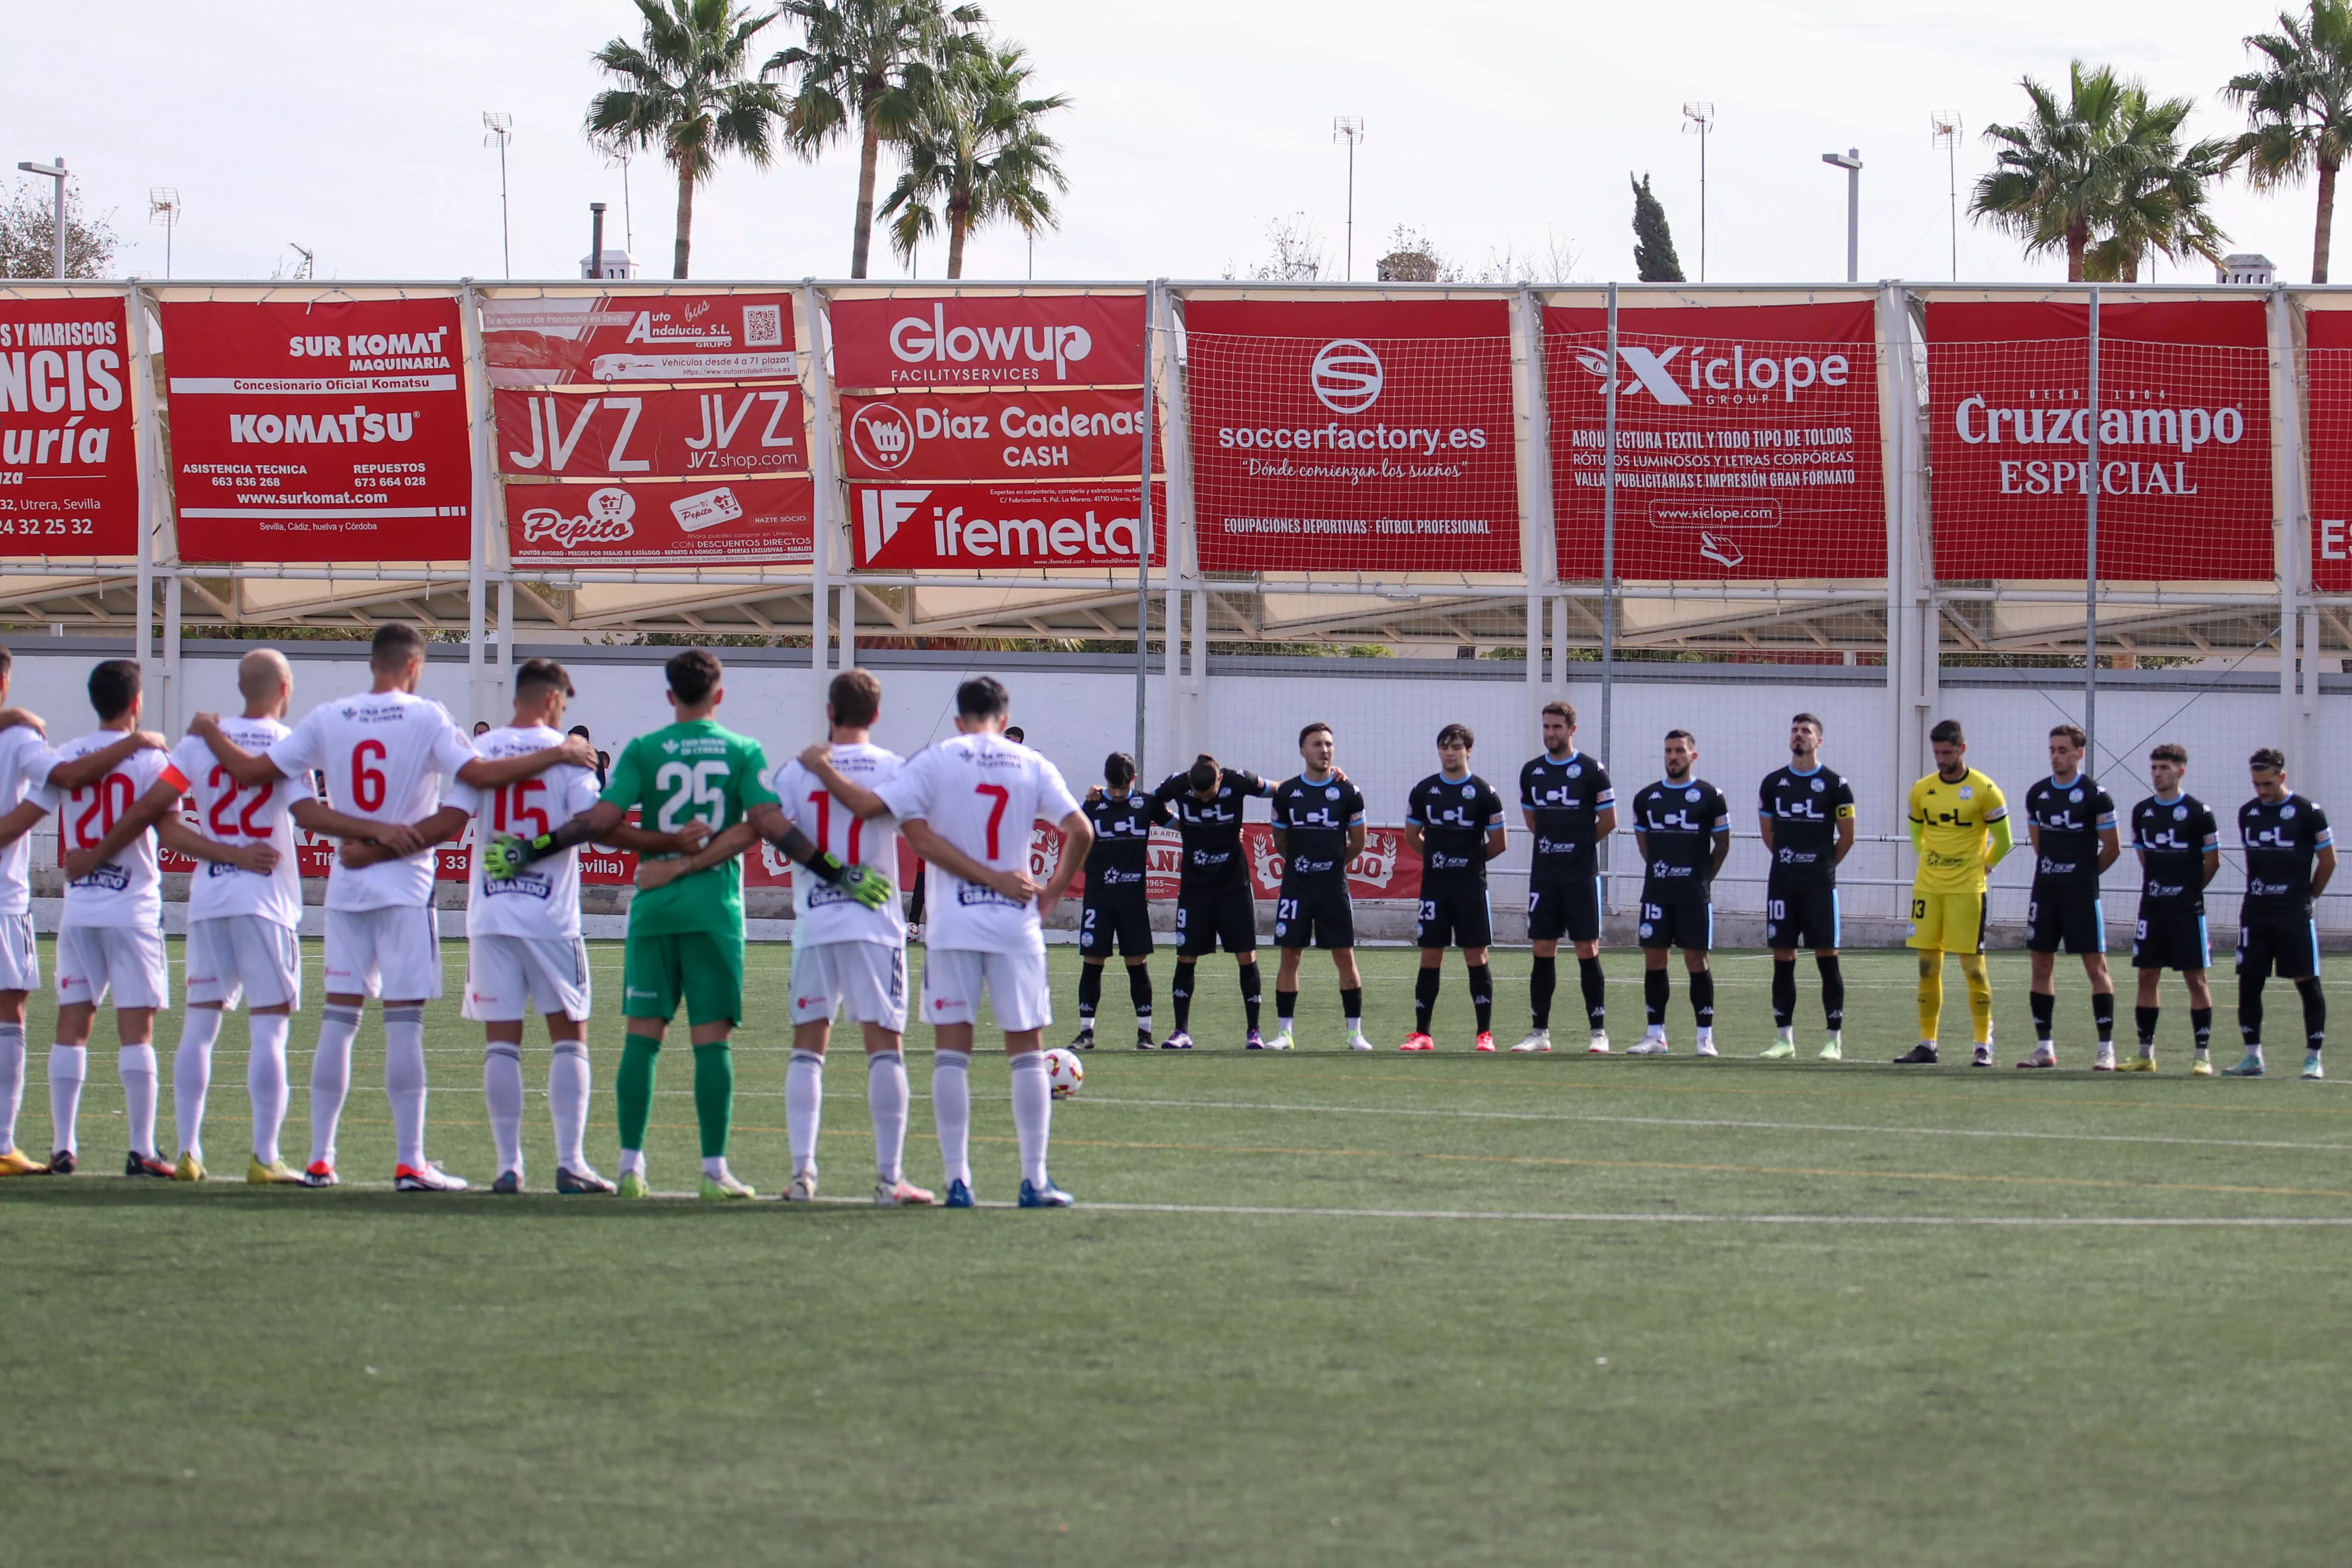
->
[882,45,1070,277]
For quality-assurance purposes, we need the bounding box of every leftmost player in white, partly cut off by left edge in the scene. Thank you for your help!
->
[0,647,165,1176]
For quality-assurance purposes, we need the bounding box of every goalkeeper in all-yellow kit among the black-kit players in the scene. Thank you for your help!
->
[1896,719,2011,1067]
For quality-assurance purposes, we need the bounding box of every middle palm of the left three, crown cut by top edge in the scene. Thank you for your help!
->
[771,0,985,277]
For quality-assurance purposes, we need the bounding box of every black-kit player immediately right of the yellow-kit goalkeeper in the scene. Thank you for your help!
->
[2018,724,2124,1067]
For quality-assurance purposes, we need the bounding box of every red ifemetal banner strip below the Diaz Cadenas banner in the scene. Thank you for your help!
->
[849,479,1167,571]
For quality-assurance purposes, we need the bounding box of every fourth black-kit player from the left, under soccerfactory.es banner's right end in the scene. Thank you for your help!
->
[1397,724,1505,1051]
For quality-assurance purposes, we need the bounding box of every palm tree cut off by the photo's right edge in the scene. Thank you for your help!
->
[2222,0,2352,282]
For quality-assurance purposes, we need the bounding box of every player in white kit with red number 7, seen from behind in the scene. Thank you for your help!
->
[842,675,1094,1208]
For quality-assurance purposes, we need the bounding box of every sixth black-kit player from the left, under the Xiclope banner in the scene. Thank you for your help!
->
[1628,729,1731,1056]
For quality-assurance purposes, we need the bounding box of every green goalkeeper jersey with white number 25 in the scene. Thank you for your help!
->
[604,719,776,940]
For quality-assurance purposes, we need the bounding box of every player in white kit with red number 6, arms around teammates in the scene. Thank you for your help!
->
[193,621,595,1192]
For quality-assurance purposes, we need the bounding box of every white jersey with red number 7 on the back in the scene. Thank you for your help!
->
[875,731,1077,954]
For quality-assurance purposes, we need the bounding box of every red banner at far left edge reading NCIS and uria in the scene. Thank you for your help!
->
[0,299,139,555]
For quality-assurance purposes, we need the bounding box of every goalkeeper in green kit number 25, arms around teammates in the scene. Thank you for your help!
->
[482,649,894,1199]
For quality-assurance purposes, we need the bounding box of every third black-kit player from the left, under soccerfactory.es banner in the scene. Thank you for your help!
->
[1265,722,1371,1051]
